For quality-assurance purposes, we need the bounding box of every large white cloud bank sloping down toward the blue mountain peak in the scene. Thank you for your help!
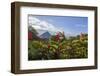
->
[29,16,62,32]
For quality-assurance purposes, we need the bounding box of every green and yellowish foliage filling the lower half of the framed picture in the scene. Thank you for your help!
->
[28,34,88,60]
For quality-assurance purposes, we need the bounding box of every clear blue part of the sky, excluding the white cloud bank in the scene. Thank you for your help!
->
[29,15,88,35]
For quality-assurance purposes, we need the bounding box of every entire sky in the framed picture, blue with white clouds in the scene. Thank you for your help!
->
[28,15,88,36]
